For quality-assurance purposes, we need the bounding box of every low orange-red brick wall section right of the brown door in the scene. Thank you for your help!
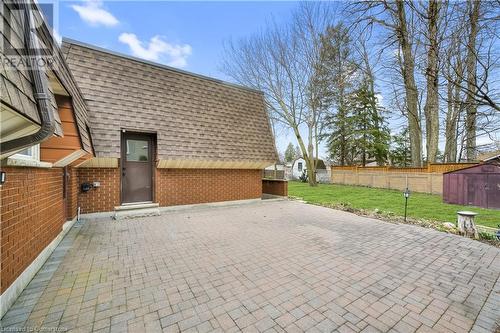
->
[155,169,262,206]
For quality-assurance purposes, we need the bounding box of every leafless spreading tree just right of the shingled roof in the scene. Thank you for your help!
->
[222,3,332,186]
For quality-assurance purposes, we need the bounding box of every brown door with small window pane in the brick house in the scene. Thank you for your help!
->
[121,133,153,203]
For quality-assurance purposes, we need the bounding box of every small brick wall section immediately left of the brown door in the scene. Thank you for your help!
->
[78,168,120,214]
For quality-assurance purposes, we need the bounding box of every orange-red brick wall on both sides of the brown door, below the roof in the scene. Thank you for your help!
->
[77,168,262,214]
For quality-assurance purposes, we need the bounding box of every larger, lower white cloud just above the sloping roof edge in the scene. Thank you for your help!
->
[118,33,192,68]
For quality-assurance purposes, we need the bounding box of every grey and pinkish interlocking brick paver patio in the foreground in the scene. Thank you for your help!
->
[2,201,500,332]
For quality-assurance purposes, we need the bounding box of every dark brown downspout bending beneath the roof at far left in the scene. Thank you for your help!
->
[0,0,55,155]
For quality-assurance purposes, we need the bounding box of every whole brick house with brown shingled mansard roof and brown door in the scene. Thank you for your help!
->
[0,3,277,317]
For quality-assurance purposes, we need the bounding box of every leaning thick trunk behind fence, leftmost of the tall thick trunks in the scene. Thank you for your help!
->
[396,1,422,167]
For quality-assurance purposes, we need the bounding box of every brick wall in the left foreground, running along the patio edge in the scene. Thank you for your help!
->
[0,167,66,293]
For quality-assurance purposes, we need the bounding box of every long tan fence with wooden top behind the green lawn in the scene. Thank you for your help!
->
[332,163,477,194]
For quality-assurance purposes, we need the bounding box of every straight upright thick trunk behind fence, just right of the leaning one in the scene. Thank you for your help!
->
[424,0,440,163]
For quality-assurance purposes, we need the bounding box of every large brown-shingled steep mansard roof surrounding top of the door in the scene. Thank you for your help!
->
[63,39,276,167]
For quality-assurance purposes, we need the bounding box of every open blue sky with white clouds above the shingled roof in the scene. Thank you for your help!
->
[54,0,297,151]
